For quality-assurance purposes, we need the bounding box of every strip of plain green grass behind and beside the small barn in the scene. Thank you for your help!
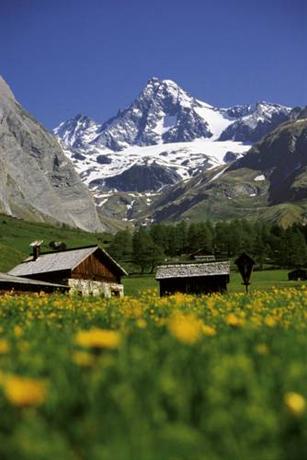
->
[123,270,304,296]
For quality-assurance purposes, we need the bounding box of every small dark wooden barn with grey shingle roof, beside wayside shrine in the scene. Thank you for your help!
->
[156,262,230,296]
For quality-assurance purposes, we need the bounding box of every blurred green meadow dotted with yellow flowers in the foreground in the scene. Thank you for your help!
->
[0,288,307,460]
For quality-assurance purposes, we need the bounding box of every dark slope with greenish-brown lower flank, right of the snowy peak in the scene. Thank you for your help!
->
[144,108,307,226]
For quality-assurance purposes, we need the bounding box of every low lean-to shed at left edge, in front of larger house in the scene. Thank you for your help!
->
[0,273,69,295]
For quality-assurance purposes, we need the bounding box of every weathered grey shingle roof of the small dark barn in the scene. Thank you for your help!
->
[156,262,230,280]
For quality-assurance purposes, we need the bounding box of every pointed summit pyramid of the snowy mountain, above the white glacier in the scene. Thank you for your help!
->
[95,78,235,151]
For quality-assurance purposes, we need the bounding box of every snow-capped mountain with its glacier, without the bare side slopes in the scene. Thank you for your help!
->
[54,78,290,195]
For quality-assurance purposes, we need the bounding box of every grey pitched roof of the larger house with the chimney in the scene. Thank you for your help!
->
[8,245,127,276]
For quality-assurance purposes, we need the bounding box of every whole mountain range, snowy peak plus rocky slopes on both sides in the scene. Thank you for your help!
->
[0,74,300,231]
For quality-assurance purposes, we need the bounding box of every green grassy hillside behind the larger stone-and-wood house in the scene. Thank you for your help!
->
[0,215,109,272]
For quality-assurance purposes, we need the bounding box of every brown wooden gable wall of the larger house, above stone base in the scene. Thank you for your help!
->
[71,254,120,283]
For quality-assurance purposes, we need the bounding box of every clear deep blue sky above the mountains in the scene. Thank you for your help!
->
[0,0,307,128]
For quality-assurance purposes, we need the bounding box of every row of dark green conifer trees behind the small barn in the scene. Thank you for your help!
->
[108,219,307,273]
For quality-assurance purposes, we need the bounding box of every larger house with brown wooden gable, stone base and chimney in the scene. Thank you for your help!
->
[9,245,127,297]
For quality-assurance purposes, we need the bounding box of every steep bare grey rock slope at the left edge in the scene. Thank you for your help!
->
[0,77,103,231]
